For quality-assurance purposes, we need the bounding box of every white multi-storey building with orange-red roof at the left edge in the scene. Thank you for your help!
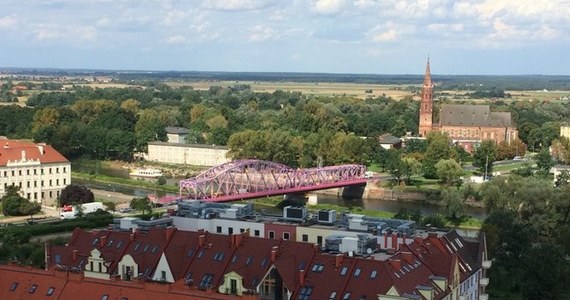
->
[0,139,71,205]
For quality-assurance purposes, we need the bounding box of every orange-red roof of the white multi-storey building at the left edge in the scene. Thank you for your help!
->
[0,139,68,166]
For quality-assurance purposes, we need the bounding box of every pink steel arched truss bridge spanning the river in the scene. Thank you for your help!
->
[180,159,366,202]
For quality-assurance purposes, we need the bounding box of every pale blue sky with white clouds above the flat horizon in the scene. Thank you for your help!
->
[0,0,570,75]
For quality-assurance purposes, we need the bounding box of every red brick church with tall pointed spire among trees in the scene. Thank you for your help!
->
[418,59,518,151]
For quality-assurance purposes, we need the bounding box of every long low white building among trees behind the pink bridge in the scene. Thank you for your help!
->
[146,142,231,166]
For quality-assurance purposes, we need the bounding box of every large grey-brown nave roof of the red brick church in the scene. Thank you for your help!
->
[439,105,515,127]
